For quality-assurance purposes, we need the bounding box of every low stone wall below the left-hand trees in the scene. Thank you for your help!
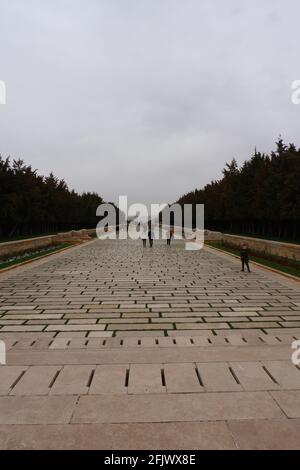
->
[0,229,96,259]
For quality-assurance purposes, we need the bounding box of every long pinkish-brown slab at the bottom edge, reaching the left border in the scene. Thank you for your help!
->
[0,422,236,450]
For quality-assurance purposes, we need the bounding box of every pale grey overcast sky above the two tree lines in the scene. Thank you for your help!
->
[0,0,300,203]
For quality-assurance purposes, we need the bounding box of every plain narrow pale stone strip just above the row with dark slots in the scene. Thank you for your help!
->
[8,345,291,366]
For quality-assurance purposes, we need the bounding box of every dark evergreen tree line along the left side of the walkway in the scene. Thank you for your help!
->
[0,156,103,238]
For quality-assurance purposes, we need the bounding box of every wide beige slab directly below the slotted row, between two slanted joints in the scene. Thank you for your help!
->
[72,392,284,423]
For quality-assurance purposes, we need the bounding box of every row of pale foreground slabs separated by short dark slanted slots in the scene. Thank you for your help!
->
[0,360,300,396]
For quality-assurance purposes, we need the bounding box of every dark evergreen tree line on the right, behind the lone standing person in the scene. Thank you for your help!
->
[178,138,300,241]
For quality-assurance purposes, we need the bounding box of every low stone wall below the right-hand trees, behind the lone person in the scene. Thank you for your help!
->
[213,233,300,261]
